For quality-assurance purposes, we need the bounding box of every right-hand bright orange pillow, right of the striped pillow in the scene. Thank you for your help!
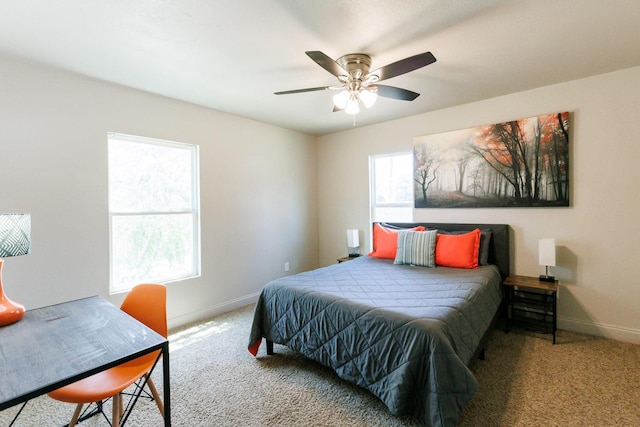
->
[436,228,480,268]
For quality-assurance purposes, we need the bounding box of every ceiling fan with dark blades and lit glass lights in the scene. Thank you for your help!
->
[275,50,436,114]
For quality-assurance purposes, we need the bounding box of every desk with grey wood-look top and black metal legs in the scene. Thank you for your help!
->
[0,296,171,426]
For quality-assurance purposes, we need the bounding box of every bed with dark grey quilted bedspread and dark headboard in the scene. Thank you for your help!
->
[249,223,510,426]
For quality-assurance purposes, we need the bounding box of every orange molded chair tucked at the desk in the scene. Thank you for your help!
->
[49,284,167,427]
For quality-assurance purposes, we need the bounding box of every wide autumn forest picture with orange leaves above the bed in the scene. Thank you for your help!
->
[413,112,569,208]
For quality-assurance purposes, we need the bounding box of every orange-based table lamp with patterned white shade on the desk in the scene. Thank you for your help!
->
[0,214,31,326]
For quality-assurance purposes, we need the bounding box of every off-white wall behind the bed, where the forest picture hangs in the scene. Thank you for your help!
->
[318,68,640,343]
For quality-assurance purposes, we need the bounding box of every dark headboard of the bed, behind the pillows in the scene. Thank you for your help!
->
[381,222,511,278]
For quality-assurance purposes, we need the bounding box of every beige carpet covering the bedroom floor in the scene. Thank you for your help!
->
[0,306,640,427]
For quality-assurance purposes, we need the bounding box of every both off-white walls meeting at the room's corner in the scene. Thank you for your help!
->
[0,51,640,343]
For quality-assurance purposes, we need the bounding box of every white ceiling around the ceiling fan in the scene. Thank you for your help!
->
[0,0,640,135]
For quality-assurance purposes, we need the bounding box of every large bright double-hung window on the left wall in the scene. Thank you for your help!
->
[108,133,200,293]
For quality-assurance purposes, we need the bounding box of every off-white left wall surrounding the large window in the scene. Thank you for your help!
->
[0,57,318,326]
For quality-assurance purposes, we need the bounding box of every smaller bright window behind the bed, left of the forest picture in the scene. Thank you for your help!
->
[369,152,413,222]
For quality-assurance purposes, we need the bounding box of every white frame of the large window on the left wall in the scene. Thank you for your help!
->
[107,132,201,295]
